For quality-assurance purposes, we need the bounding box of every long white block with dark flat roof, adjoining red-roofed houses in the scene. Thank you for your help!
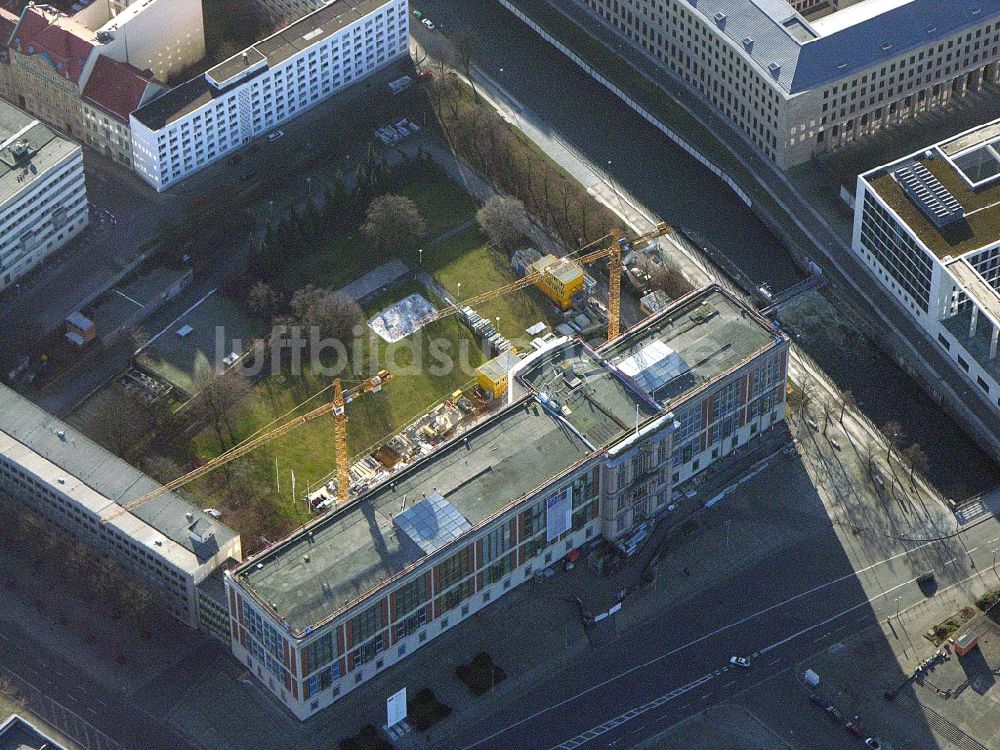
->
[130,0,409,190]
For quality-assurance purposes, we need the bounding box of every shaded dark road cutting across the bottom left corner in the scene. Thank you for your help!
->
[0,622,194,750]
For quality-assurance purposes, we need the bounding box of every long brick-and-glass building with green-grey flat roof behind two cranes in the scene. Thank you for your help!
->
[226,286,788,719]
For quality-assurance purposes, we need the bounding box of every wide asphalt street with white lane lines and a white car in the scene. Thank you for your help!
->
[455,519,1000,750]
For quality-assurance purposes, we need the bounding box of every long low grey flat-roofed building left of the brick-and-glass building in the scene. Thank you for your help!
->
[0,386,242,628]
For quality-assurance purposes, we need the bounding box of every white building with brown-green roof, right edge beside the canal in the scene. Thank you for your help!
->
[852,120,1000,411]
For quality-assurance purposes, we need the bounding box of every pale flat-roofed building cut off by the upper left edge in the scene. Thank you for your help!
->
[0,100,88,290]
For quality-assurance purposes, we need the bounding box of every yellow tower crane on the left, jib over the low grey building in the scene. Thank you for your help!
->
[101,370,392,524]
